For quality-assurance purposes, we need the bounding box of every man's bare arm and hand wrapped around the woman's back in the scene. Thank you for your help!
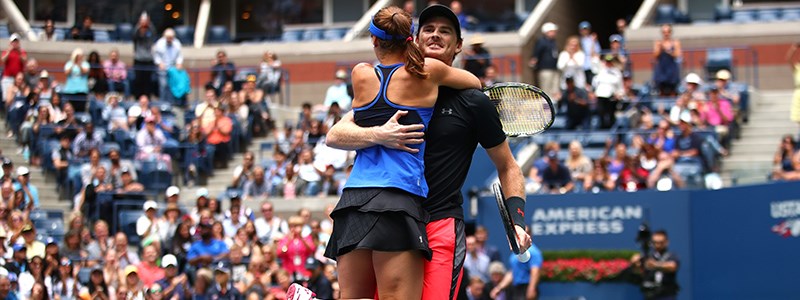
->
[325,111,424,153]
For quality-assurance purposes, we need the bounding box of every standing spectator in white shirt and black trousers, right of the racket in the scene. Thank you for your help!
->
[592,54,624,129]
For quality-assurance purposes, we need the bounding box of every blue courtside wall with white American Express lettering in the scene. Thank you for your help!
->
[472,182,800,299]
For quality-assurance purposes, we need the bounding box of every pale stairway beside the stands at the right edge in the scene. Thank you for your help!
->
[721,90,798,186]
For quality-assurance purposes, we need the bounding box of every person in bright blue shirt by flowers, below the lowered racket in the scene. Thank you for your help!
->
[492,244,543,300]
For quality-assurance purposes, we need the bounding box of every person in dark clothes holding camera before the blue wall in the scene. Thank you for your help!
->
[631,230,680,300]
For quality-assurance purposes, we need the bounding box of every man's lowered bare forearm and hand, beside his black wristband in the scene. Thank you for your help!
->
[486,140,531,251]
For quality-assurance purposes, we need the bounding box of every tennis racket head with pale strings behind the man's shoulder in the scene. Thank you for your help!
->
[483,82,555,137]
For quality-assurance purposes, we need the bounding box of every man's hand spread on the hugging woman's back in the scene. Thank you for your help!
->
[375,110,425,153]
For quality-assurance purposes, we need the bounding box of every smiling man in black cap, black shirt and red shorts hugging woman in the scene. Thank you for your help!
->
[327,5,531,299]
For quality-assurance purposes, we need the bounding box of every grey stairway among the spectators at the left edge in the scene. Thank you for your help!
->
[0,134,72,212]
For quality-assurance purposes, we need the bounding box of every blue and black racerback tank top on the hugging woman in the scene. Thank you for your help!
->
[345,64,433,197]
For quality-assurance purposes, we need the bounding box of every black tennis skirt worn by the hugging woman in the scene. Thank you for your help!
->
[325,188,432,260]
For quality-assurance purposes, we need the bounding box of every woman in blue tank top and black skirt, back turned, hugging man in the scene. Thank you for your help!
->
[325,6,481,299]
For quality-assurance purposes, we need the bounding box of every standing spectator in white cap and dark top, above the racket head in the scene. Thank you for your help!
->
[528,22,561,99]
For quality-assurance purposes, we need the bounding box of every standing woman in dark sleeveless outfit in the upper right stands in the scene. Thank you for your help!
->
[653,24,683,96]
